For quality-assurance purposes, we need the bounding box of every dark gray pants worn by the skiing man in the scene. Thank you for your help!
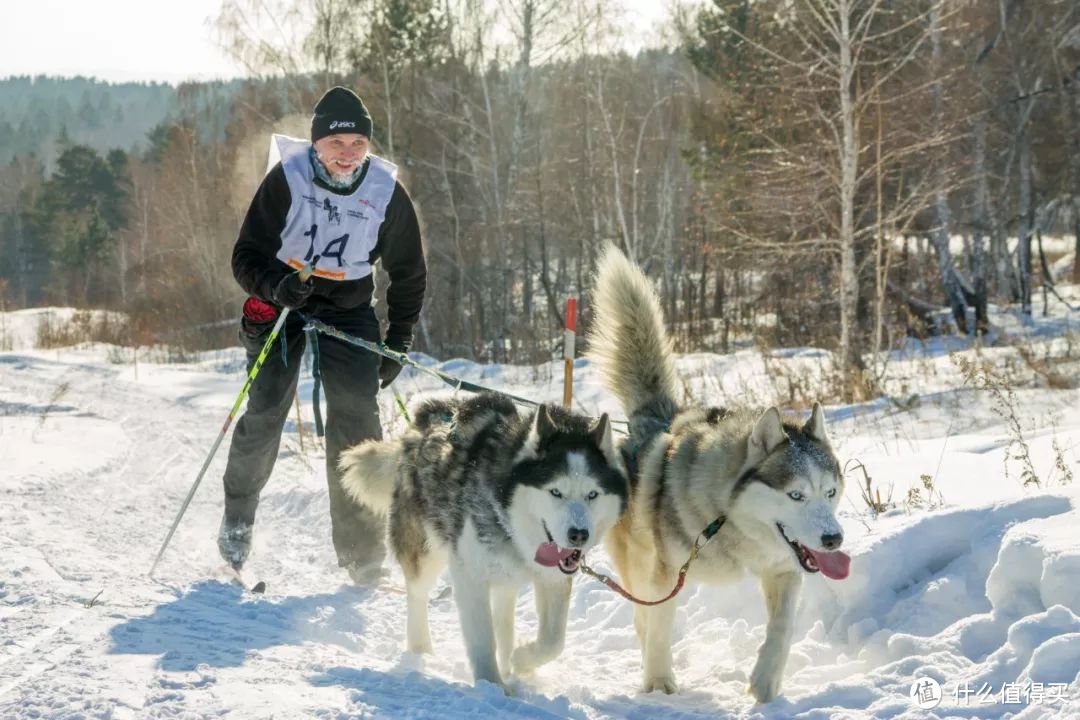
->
[225,308,386,567]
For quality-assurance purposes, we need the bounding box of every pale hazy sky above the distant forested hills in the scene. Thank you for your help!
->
[0,0,667,82]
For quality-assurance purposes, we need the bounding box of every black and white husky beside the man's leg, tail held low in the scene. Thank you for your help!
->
[340,393,630,688]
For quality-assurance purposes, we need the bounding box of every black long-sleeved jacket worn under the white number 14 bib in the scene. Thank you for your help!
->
[232,158,428,347]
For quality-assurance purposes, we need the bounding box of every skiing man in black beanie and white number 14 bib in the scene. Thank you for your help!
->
[218,87,427,584]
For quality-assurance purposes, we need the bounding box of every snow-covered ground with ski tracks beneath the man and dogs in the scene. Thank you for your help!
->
[0,311,1080,720]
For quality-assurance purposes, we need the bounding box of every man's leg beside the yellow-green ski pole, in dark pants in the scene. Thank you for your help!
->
[218,316,305,567]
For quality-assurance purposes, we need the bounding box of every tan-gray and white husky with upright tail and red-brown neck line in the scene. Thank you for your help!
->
[589,245,850,703]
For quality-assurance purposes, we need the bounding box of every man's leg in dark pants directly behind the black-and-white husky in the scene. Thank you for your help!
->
[319,310,387,582]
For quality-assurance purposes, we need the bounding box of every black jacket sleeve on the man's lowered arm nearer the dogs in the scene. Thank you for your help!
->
[373,182,428,349]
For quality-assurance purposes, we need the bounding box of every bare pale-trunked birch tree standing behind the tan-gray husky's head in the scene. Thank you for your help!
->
[699,0,948,394]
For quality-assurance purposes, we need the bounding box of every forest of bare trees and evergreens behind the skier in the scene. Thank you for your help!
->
[0,0,1080,398]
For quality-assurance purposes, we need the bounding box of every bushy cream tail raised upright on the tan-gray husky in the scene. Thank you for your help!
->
[588,243,678,421]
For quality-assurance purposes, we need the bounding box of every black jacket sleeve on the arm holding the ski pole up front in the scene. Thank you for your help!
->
[232,163,292,302]
